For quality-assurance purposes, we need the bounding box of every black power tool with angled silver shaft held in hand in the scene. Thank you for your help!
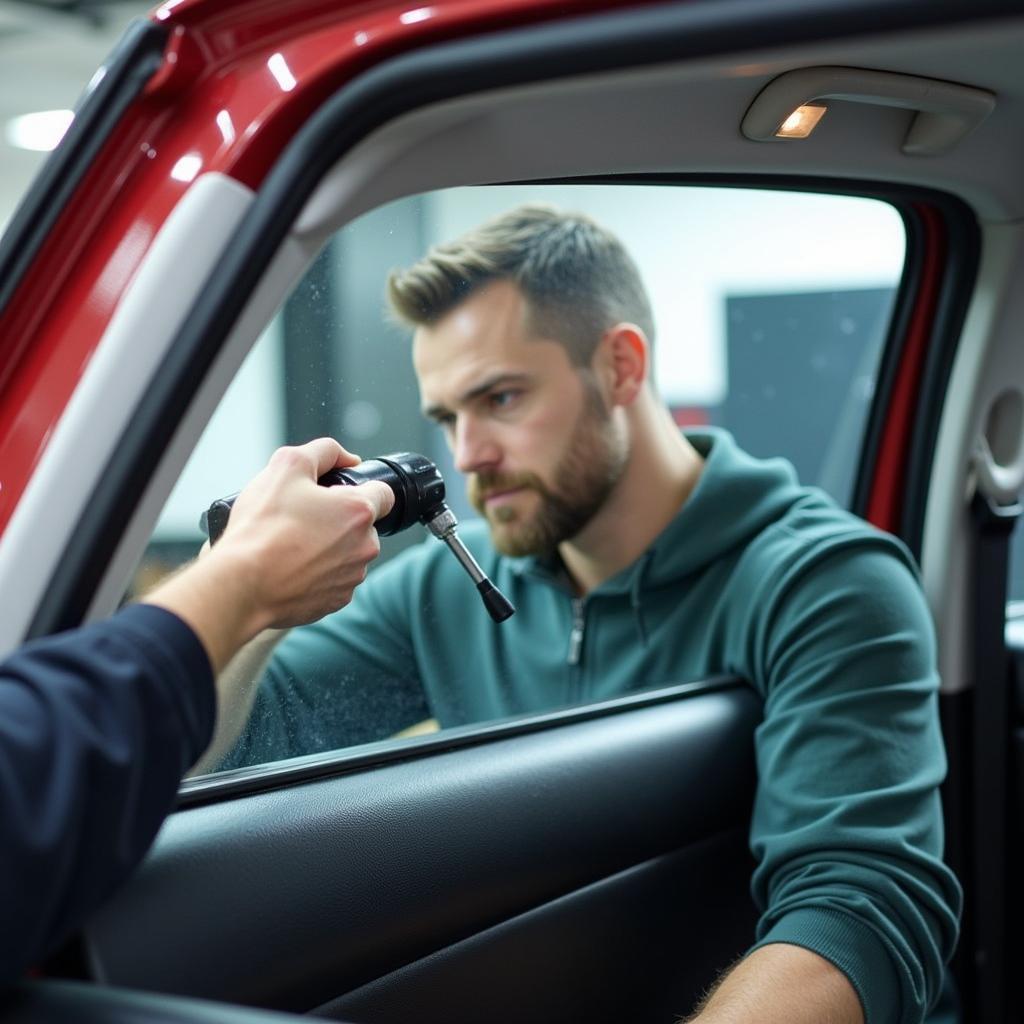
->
[199,452,515,623]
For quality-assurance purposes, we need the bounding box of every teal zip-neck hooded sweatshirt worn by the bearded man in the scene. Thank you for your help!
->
[223,429,961,1024]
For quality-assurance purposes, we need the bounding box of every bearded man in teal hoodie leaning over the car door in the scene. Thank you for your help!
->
[207,207,959,1024]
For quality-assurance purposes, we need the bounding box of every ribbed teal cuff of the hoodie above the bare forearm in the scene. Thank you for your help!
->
[751,906,902,1024]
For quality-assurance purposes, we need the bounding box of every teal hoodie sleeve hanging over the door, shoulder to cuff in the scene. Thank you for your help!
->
[751,534,961,1024]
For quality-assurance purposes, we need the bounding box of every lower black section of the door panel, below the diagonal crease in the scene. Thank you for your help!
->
[316,827,755,1024]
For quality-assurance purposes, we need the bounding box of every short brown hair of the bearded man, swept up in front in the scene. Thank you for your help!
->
[388,204,654,366]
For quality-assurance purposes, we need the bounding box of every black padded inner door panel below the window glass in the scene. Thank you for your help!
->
[87,683,760,1021]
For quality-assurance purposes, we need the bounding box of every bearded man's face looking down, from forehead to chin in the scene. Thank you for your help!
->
[413,281,628,555]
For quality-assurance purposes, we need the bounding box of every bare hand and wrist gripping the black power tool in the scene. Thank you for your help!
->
[145,437,394,672]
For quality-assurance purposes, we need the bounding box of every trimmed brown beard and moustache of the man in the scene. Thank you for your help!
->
[469,378,629,557]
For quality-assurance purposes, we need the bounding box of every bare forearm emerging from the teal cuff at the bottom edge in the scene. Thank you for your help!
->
[689,943,864,1024]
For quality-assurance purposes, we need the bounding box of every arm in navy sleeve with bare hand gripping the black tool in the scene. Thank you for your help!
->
[0,439,393,982]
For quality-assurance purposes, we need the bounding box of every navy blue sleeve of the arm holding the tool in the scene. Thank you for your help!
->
[0,605,215,982]
